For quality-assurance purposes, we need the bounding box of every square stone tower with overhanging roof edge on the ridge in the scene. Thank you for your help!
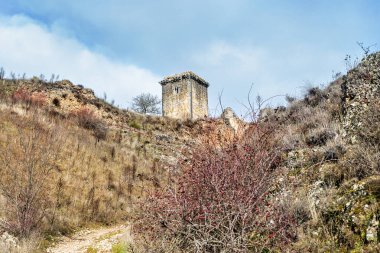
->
[160,71,209,119]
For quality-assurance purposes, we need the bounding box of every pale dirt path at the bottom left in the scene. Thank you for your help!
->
[47,225,132,253]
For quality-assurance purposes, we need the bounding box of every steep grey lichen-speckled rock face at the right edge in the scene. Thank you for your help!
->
[342,52,380,143]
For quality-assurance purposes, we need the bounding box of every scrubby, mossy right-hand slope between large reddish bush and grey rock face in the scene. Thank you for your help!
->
[265,75,380,252]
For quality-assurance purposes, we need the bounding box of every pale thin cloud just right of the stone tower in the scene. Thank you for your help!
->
[191,41,344,115]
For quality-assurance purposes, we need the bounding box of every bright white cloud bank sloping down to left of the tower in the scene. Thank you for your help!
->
[0,15,161,107]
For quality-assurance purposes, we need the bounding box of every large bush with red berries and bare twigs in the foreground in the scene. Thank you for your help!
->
[135,125,292,252]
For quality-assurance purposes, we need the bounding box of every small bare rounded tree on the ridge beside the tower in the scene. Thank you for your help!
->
[132,93,161,114]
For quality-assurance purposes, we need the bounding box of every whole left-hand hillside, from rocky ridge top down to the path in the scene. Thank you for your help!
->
[0,78,238,251]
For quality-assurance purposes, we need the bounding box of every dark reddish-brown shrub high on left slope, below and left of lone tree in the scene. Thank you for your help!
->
[71,107,108,140]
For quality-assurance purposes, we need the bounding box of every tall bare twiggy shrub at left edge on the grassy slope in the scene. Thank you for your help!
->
[0,112,59,237]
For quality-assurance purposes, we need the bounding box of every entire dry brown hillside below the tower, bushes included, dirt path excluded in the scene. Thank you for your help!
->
[0,53,380,252]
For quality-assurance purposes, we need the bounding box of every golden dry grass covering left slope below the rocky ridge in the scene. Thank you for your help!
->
[0,101,160,243]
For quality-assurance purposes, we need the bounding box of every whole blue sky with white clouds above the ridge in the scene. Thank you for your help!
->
[0,0,380,116]
